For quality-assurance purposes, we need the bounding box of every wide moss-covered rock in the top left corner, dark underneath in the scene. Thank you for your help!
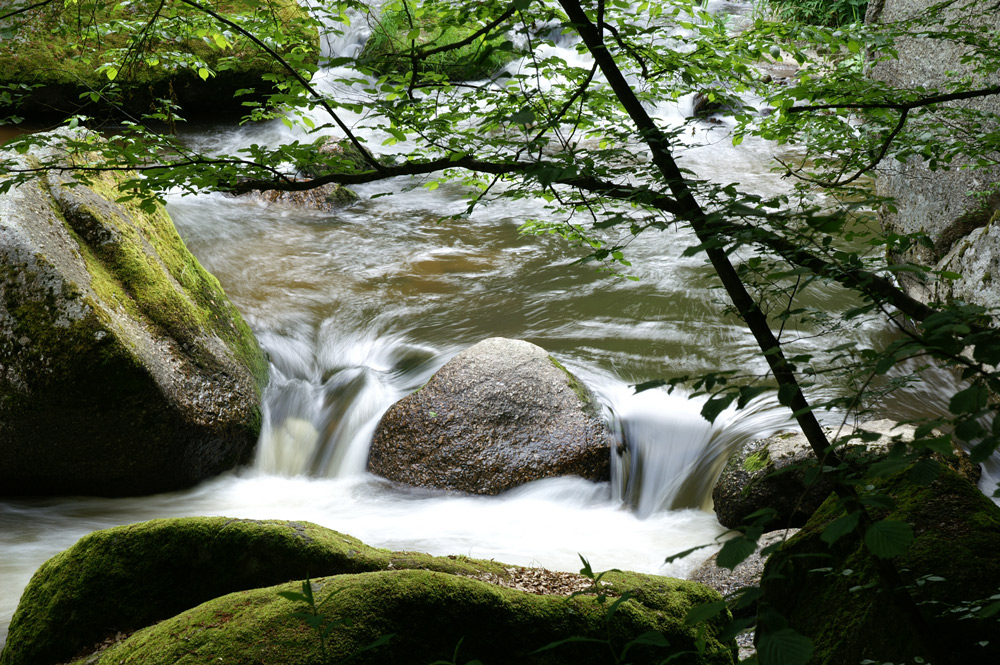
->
[0,0,319,119]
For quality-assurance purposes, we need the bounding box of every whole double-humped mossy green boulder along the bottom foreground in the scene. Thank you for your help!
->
[0,517,735,665]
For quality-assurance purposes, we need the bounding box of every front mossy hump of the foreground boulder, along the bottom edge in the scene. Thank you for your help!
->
[78,570,735,665]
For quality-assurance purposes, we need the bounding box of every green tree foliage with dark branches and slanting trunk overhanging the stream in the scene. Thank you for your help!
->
[0,0,1000,662]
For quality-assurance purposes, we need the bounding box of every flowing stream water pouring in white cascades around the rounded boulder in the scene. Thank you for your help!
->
[0,3,988,644]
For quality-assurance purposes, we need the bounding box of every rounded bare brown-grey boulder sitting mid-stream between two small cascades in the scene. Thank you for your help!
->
[368,337,612,494]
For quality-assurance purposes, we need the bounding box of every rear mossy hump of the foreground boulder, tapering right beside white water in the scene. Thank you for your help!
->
[0,517,511,665]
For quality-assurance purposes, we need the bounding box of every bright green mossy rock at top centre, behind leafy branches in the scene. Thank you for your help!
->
[360,0,516,81]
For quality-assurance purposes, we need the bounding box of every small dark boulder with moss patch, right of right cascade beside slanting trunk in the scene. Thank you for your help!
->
[712,420,914,530]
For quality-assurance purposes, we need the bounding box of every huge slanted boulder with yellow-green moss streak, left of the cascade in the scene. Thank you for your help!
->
[0,131,267,496]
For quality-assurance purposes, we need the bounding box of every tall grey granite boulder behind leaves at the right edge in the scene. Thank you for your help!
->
[866,0,1000,300]
